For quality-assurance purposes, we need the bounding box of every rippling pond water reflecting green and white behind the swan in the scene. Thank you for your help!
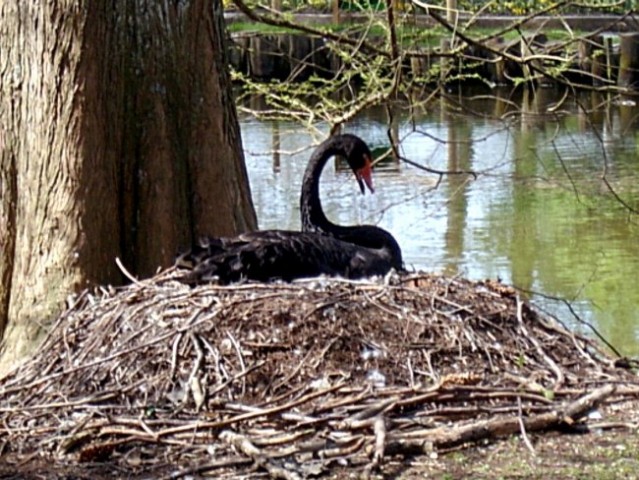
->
[241,89,639,356]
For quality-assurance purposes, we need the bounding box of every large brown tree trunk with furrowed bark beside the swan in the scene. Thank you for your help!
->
[0,0,256,369]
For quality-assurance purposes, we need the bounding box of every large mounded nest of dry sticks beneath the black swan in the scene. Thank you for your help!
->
[0,271,639,479]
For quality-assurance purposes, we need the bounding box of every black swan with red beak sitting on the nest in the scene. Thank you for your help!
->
[176,134,403,284]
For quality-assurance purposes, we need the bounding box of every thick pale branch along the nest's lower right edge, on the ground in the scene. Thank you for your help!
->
[386,385,615,455]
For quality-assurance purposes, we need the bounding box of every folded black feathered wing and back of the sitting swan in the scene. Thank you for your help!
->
[178,230,392,284]
